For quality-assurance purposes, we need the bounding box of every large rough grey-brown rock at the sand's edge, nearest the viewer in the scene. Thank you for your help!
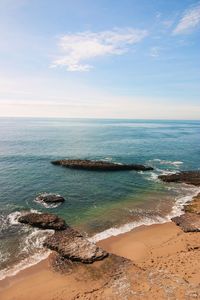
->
[44,227,108,263]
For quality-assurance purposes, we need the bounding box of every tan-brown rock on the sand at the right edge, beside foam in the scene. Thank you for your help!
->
[172,213,200,232]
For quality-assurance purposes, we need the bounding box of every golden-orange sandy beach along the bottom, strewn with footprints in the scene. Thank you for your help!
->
[0,222,200,300]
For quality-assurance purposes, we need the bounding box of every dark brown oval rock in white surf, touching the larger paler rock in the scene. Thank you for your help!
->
[18,213,67,230]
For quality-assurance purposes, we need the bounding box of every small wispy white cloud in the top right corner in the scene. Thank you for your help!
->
[173,4,200,34]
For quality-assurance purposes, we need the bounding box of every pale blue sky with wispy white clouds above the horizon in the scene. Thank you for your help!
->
[0,0,200,119]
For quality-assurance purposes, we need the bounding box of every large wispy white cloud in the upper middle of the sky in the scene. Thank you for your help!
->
[52,28,147,71]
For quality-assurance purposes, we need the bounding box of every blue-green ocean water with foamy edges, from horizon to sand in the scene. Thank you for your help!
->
[0,118,200,279]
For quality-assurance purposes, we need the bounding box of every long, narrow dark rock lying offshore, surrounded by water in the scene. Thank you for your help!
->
[51,159,153,171]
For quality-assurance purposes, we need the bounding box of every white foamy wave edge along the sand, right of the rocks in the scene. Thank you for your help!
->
[89,185,200,243]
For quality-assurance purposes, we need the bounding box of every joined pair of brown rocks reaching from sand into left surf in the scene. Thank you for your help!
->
[18,213,108,264]
